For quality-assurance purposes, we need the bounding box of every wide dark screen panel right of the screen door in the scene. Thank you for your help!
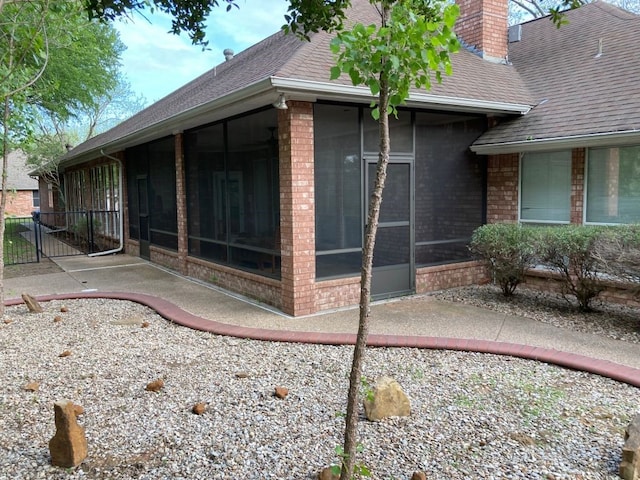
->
[415,113,486,265]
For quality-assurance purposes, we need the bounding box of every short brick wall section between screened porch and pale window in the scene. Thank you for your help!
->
[487,153,520,223]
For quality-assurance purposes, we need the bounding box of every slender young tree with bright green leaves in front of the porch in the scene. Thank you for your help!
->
[286,0,459,480]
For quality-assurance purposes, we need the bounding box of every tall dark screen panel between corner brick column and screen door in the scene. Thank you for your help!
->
[314,105,363,255]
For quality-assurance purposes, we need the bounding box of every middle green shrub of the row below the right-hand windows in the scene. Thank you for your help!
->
[537,225,606,311]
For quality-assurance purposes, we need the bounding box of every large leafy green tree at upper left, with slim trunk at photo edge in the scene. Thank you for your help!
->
[0,0,123,314]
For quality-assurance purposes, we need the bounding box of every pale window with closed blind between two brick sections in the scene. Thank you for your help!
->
[520,150,571,223]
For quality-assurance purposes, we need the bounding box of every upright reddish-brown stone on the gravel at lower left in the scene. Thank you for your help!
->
[49,400,87,468]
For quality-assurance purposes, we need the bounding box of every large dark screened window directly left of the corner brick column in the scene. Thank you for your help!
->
[185,109,280,277]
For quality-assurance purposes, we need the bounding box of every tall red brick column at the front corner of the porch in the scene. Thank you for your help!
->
[278,101,316,316]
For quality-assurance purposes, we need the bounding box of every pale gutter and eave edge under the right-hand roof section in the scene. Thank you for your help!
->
[470,130,640,155]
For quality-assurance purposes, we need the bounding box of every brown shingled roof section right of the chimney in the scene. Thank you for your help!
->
[472,1,640,153]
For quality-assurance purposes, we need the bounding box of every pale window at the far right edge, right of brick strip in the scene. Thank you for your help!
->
[586,146,640,224]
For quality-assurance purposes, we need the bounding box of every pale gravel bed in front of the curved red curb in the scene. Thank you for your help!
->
[0,300,640,480]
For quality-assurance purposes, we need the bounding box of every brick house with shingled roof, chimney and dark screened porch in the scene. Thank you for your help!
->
[52,0,640,316]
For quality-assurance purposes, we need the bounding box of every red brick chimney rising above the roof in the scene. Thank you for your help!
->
[456,0,509,62]
